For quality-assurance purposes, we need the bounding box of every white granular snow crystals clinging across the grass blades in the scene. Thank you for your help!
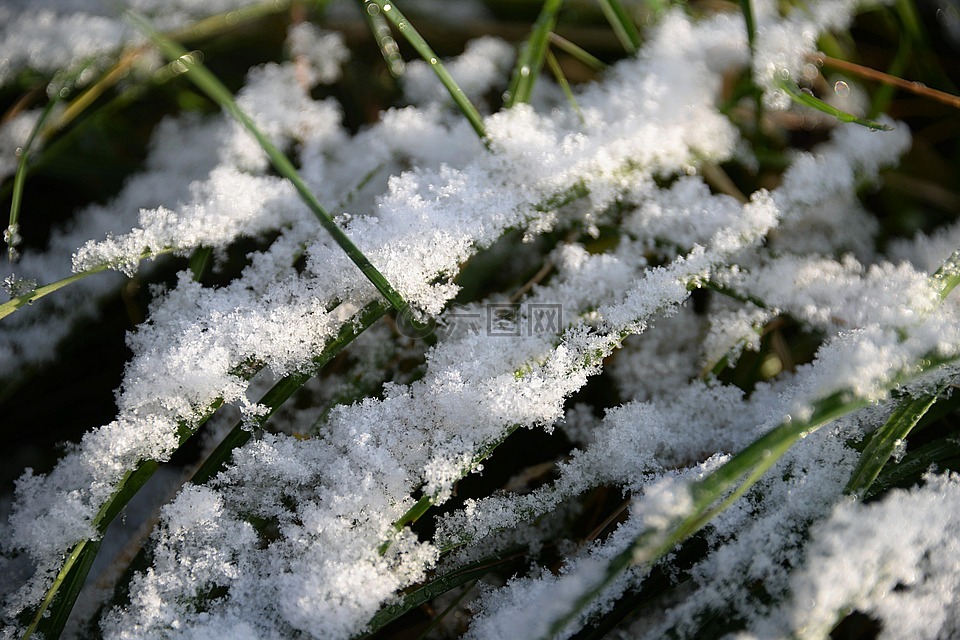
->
[0,0,960,640]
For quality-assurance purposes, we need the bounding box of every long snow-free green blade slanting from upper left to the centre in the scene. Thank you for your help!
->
[126,11,409,312]
